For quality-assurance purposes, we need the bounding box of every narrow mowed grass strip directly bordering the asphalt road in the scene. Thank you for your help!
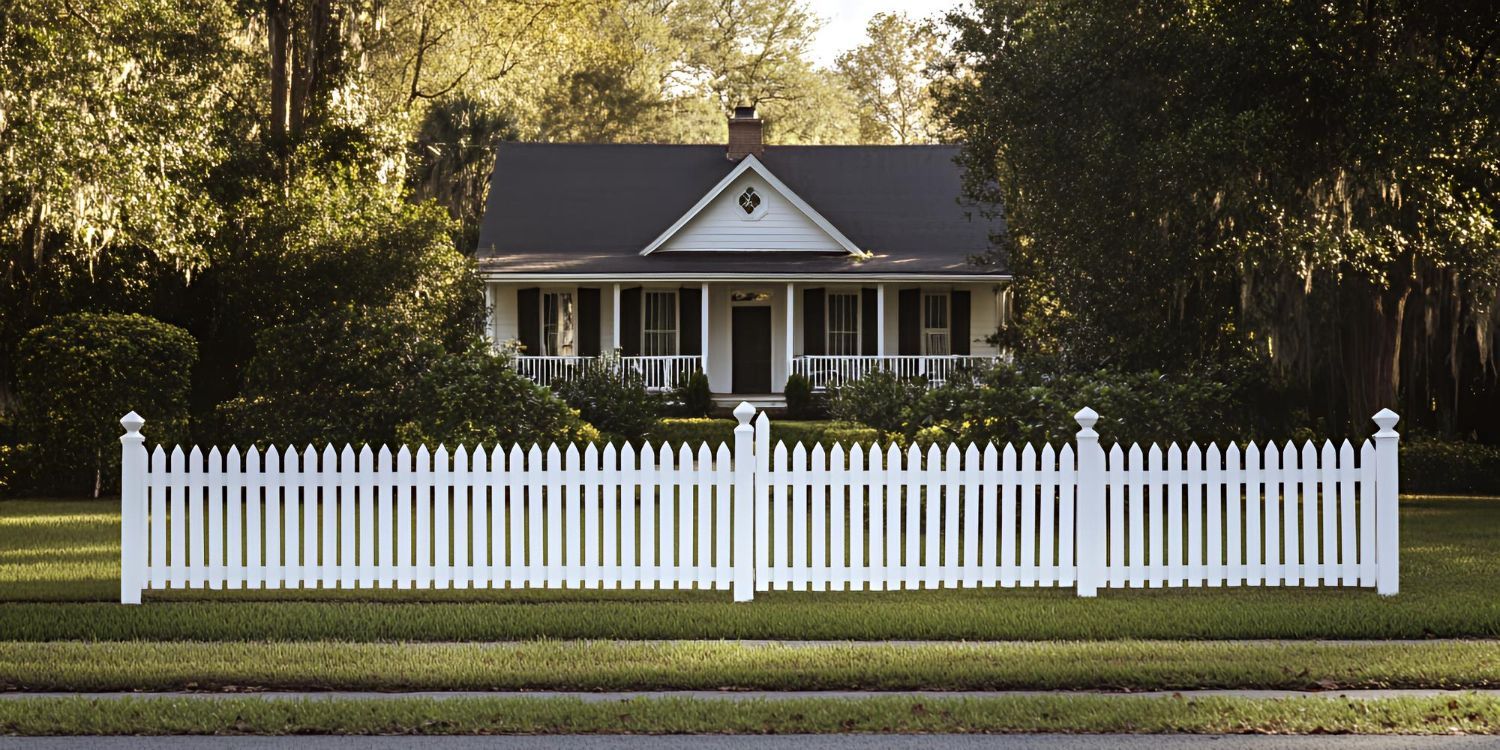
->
[0,695,1500,735]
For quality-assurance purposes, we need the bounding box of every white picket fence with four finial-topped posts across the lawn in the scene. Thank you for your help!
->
[120,404,1400,603]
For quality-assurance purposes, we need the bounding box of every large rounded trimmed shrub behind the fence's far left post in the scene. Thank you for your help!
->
[17,312,198,497]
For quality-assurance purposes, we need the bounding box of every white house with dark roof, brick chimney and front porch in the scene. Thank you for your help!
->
[479,108,1011,404]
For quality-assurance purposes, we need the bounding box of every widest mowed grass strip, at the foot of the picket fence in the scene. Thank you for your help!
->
[0,498,1500,642]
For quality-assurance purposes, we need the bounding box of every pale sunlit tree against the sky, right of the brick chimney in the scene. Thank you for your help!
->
[836,14,945,144]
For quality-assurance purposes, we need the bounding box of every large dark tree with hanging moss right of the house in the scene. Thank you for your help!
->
[941,0,1500,437]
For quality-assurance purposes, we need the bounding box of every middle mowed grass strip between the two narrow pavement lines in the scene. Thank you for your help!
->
[0,641,1500,692]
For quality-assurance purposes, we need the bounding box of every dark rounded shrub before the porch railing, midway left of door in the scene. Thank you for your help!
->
[552,356,662,441]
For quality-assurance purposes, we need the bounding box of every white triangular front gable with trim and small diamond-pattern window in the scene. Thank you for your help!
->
[641,156,864,257]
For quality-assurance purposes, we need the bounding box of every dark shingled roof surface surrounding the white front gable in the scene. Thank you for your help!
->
[479,143,1007,275]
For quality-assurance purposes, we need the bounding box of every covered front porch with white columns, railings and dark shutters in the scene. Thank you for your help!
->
[486,279,1010,396]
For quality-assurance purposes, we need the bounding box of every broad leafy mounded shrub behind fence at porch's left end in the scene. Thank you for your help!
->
[396,344,600,449]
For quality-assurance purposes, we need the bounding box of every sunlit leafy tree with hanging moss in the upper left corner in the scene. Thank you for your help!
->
[0,0,245,411]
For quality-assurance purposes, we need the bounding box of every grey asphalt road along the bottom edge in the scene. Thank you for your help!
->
[0,735,1500,750]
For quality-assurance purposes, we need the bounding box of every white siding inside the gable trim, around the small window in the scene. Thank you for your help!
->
[656,173,848,254]
